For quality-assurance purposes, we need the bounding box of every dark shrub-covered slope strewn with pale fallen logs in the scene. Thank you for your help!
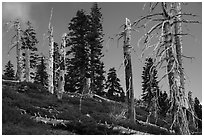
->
[2,82,182,135]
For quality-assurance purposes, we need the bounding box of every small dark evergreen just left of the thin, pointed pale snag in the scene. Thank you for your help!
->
[34,56,48,87]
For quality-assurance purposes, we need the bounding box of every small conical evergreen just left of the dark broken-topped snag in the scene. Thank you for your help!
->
[106,68,125,102]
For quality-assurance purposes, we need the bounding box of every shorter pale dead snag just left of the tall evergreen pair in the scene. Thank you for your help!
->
[57,33,67,99]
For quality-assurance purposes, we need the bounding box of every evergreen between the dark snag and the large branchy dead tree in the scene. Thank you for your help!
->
[142,58,159,109]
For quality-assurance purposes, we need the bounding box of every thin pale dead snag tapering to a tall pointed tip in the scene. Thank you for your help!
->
[48,9,54,94]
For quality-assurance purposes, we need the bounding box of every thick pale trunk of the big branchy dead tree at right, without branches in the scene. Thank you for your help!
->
[162,3,190,135]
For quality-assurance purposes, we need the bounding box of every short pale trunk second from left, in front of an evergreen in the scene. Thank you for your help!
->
[25,47,30,82]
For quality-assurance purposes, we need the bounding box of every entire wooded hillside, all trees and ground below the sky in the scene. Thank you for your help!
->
[2,2,202,135]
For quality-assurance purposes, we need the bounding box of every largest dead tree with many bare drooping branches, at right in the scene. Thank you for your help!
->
[133,2,198,134]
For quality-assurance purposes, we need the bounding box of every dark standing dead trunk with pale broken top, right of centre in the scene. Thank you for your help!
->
[123,18,135,122]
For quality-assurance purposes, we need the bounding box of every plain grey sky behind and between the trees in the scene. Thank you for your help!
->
[2,2,202,101]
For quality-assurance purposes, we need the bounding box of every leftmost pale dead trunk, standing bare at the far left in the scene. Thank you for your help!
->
[15,20,22,81]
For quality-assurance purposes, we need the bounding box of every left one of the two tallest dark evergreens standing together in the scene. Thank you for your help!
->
[65,10,90,92]
